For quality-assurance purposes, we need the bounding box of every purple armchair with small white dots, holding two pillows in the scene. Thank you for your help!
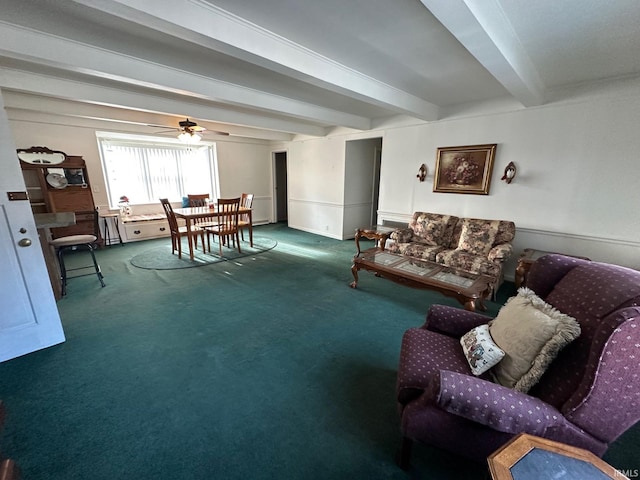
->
[396,255,640,469]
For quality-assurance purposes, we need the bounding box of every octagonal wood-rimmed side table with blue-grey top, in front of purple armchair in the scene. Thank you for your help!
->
[487,433,628,480]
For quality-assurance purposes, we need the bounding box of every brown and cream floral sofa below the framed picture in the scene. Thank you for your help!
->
[387,212,516,289]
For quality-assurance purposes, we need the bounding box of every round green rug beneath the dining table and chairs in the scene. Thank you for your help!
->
[131,235,278,270]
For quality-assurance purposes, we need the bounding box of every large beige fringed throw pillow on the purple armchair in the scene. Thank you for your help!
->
[489,287,580,393]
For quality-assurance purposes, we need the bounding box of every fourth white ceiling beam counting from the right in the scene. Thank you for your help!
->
[0,68,326,137]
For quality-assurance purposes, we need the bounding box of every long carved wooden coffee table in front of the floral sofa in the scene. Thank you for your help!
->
[351,248,495,312]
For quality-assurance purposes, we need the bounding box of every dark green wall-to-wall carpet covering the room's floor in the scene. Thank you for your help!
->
[0,225,640,480]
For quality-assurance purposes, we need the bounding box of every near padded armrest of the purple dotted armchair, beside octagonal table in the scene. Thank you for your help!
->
[427,370,566,436]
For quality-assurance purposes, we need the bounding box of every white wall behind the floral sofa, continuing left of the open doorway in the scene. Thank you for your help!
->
[288,79,640,278]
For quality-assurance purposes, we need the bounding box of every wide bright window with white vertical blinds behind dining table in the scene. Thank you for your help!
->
[98,132,219,208]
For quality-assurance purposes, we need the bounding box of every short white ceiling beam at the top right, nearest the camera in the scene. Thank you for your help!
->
[420,0,544,107]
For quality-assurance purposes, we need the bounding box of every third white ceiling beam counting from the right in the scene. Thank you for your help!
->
[0,23,364,130]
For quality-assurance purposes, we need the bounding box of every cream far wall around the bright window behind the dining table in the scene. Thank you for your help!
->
[10,118,273,224]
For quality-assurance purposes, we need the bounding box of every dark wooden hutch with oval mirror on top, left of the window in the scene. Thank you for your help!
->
[18,147,102,244]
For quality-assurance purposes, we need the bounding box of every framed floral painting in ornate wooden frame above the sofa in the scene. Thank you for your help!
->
[433,143,497,195]
